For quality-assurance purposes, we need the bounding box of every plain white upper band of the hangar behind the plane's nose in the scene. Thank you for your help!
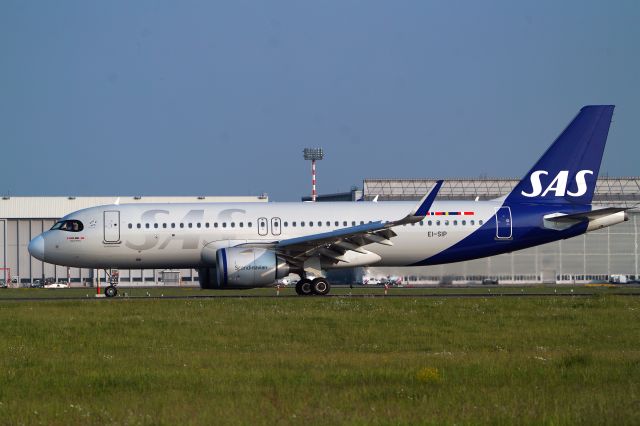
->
[0,195,269,219]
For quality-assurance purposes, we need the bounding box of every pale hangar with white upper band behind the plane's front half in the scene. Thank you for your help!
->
[0,195,268,286]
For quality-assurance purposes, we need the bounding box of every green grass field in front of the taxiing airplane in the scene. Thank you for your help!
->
[0,289,640,424]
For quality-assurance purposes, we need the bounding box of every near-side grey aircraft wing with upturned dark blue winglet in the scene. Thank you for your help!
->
[274,180,443,262]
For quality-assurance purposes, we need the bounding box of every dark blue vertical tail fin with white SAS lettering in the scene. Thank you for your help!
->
[506,105,614,204]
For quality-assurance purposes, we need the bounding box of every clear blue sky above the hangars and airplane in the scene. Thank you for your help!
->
[0,0,640,201]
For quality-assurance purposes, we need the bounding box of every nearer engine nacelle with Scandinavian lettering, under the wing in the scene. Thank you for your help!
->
[216,247,289,288]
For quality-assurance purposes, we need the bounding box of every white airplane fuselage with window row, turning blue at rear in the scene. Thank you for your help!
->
[31,201,624,269]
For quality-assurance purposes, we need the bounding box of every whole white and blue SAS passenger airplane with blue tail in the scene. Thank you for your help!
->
[29,105,627,297]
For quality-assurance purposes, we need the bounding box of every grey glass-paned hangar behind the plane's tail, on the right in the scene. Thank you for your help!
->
[363,177,640,283]
